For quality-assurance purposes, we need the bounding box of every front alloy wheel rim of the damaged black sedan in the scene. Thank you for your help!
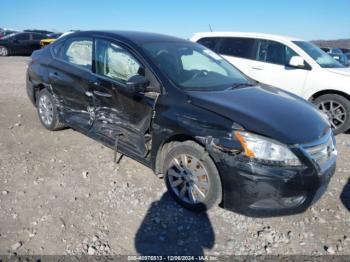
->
[167,154,210,204]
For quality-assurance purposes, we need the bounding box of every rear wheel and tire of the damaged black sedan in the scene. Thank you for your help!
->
[36,89,65,131]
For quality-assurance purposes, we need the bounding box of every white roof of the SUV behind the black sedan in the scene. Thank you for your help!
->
[192,32,303,41]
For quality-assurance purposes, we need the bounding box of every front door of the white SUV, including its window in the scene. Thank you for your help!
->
[250,40,309,95]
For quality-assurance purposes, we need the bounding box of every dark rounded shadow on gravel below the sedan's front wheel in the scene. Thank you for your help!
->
[135,193,215,256]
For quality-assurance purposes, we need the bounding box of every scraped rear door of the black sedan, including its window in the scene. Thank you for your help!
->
[49,37,94,130]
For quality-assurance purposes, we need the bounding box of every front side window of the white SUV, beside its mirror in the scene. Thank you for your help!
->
[256,40,297,65]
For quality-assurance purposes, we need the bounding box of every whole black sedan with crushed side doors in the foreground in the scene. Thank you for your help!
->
[27,31,336,216]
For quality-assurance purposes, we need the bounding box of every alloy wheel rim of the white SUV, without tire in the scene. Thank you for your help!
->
[318,100,347,129]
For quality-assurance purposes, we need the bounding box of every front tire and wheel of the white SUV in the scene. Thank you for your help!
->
[314,94,350,135]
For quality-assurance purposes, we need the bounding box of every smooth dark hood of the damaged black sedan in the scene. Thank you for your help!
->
[187,86,329,145]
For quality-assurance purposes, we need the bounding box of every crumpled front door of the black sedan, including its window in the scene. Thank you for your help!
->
[91,39,157,157]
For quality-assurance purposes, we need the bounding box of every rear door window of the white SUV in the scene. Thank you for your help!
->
[218,37,255,59]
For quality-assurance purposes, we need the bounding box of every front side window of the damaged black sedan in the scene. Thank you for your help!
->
[95,37,144,83]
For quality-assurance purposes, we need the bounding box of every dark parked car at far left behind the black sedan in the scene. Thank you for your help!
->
[0,32,46,56]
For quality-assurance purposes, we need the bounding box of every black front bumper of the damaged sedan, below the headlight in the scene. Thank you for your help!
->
[213,135,336,217]
